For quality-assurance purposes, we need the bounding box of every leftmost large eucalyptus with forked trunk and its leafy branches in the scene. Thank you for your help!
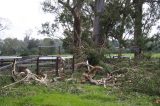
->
[43,0,98,58]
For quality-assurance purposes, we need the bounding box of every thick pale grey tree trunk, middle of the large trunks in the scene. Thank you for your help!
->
[93,0,105,46]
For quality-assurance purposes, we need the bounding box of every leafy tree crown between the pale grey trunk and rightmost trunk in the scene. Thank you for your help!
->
[97,0,133,56]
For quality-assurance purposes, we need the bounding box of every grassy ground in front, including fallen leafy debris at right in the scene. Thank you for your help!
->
[0,54,160,106]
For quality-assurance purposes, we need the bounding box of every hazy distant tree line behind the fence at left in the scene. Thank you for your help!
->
[0,36,63,56]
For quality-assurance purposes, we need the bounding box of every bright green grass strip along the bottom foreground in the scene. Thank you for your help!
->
[0,85,156,106]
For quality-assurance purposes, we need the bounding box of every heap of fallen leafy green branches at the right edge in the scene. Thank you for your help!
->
[122,61,160,95]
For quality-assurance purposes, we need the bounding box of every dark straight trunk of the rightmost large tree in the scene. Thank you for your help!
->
[133,0,144,59]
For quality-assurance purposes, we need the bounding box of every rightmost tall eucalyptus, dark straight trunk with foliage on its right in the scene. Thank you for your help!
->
[132,0,160,58]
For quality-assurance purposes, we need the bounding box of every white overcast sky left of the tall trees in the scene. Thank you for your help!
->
[0,0,59,40]
